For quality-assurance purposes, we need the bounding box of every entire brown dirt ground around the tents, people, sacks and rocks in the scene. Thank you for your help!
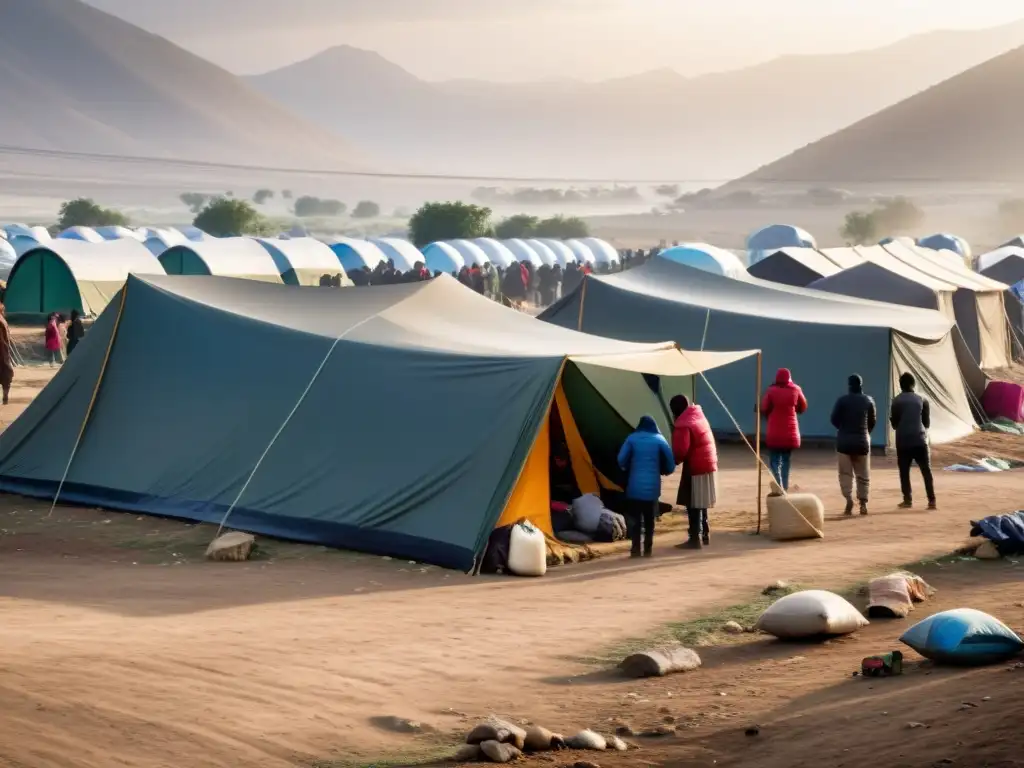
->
[0,358,1024,768]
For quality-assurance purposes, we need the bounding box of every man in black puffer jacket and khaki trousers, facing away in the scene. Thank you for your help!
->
[831,374,878,515]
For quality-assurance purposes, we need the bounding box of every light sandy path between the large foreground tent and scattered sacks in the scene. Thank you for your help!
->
[0,453,1024,768]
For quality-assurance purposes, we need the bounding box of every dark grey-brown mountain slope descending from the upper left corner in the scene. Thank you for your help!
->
[0,0,354,168]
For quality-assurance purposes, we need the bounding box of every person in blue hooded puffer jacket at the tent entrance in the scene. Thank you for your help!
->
[618,416,676,557]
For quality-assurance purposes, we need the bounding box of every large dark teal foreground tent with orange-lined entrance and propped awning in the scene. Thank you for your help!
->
[0,276,752,570]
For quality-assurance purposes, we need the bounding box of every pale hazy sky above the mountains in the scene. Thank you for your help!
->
[87,0,1024,81]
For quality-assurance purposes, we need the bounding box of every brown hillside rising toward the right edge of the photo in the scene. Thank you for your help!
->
[741,47,1024,183]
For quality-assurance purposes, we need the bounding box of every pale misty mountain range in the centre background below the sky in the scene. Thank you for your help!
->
[243,23,1024,180]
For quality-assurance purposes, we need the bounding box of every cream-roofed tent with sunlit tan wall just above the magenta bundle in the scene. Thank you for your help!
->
[877,241,1011,370]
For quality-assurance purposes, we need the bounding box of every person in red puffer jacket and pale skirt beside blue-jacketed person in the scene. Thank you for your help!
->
[669,394,718,549]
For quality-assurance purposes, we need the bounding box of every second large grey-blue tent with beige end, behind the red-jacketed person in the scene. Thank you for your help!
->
[541,258,974,445]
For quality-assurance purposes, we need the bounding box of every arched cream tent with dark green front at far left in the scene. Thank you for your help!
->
[4,238,164,316]
